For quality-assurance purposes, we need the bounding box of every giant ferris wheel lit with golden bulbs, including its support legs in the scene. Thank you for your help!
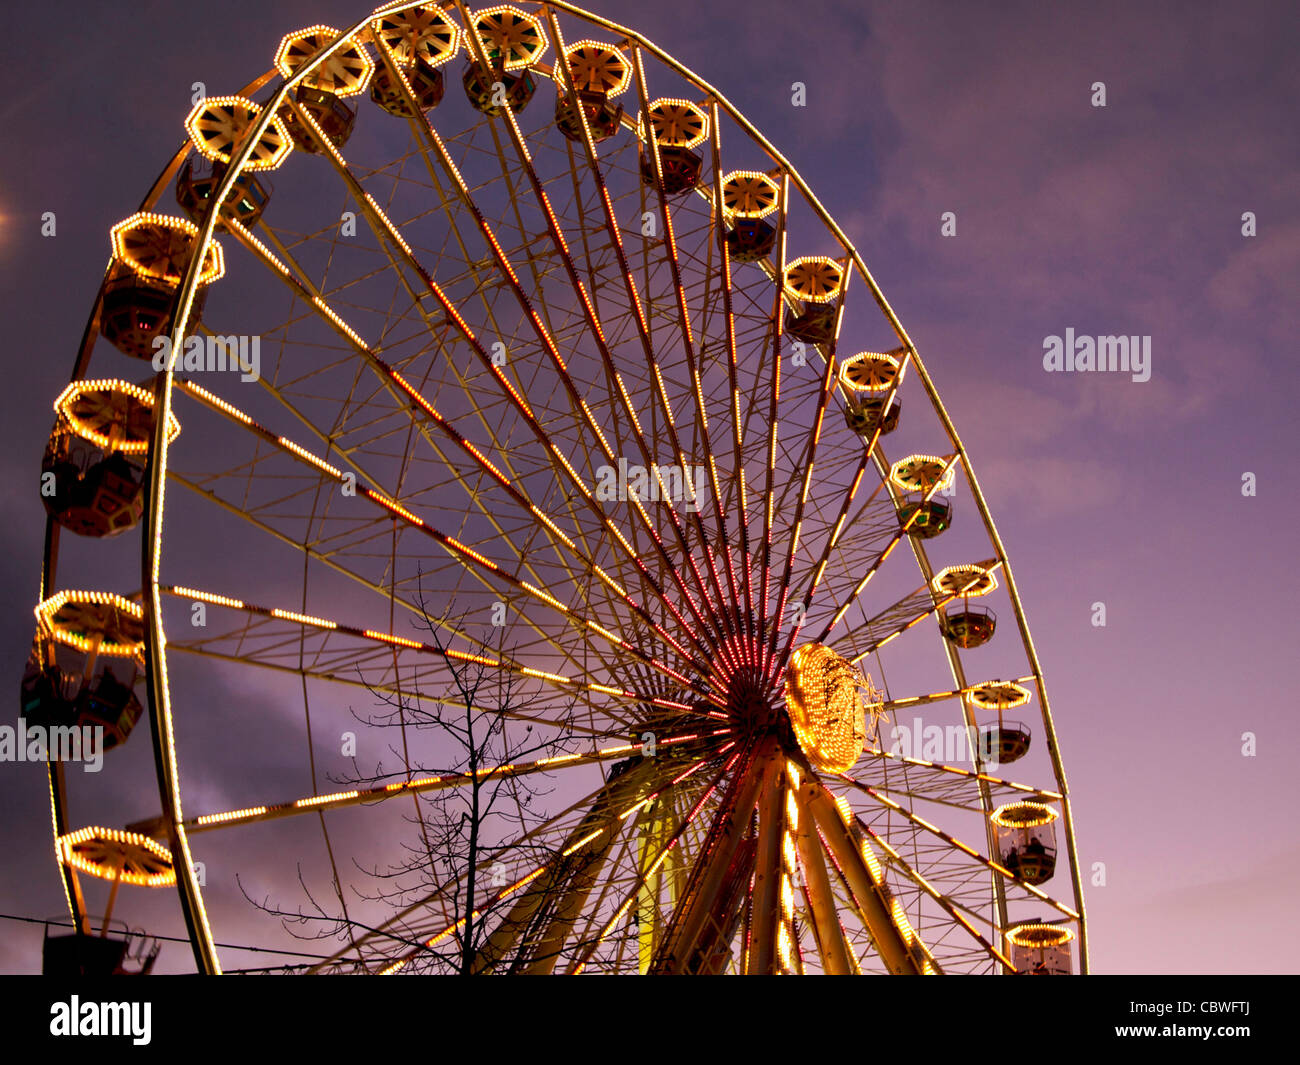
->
[22,0,1087,974]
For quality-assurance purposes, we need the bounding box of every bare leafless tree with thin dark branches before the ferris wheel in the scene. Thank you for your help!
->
[246,588,585,975]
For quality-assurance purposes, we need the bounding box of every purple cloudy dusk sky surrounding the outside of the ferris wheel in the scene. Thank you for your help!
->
[0,0,1300,973]
